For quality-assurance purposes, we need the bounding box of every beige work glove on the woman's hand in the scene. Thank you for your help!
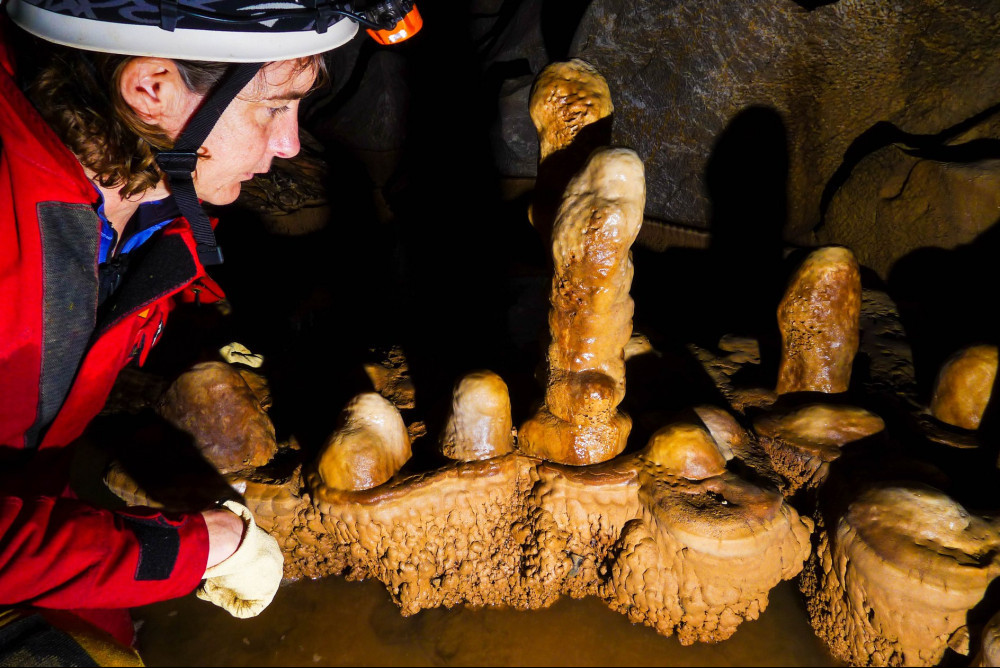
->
[197,501,284,619]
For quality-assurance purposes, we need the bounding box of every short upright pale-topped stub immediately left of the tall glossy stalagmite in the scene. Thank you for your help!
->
[441,371,514,462]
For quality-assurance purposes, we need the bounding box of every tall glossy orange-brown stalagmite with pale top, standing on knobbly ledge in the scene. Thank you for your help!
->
[519,148,646,465]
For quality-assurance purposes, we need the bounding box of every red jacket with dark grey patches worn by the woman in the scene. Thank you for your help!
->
[0,22,215,608]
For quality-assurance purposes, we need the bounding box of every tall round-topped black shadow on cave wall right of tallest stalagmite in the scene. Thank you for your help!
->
[633,107,789,396]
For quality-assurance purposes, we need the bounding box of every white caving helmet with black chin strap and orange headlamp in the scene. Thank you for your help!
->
[0,0,422,265]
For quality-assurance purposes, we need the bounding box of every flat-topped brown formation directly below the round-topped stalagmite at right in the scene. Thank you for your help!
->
[754,404,885,495]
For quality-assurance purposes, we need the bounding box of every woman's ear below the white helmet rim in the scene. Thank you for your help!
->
[118,56,201,139]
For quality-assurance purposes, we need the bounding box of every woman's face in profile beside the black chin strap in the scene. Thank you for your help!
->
[170,61,316,204]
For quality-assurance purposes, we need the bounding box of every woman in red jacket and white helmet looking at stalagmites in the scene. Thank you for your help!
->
[0,0,412,660]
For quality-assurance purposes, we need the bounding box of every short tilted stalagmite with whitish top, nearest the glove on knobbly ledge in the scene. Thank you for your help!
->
[316,392,411,491]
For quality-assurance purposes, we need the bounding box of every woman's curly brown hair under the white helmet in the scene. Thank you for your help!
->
[27,44,328,198]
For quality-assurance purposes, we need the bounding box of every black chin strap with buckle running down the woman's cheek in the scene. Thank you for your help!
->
[156,63,264,267]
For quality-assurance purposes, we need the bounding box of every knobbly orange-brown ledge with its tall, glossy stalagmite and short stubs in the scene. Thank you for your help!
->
[101,57,812,644]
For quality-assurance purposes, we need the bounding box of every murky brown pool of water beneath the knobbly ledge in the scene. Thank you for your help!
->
[134,577,839,666]
